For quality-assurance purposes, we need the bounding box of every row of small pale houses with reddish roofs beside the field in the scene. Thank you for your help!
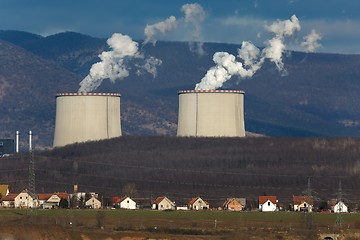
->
[0,185,348,212]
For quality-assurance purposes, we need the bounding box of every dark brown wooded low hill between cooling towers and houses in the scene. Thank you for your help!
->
[0,136,360,208]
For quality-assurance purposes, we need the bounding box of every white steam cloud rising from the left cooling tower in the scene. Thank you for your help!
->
[78,33,161,93]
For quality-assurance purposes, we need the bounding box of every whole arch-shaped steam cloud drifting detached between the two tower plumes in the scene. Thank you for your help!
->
[144,3,205,55]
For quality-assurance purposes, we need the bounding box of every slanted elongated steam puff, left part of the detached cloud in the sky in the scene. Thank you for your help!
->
[144,16,177,45]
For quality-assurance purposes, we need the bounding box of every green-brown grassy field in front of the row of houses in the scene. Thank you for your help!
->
[0,209,360,239]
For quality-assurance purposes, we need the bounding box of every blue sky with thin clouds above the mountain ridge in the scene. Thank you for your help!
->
[0,0,360,54]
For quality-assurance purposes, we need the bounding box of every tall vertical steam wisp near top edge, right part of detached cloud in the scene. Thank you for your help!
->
[181,3,205,55]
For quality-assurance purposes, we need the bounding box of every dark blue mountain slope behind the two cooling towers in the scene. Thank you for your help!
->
[0,31,360,147]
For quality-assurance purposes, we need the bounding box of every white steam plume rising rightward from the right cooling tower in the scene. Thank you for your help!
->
[195,15,301,90]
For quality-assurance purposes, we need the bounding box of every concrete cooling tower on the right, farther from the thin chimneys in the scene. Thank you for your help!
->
[177,90,245,137]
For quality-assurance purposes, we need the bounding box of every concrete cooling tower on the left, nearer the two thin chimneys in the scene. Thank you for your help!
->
[53,93,121,147]
